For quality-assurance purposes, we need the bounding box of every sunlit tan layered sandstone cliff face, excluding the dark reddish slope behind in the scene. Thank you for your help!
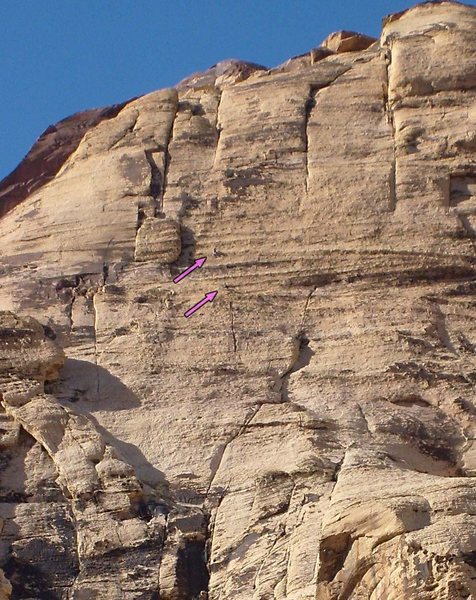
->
[0,2,476,600]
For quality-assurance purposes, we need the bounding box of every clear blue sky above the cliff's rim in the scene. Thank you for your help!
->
[0,0,476,179]
